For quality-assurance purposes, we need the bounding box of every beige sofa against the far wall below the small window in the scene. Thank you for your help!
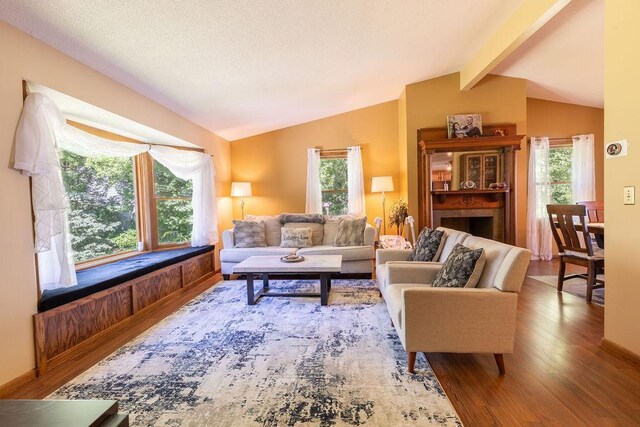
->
[220,215,376,280]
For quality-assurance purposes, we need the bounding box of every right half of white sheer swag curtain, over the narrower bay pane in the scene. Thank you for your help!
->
[149,145,218,246]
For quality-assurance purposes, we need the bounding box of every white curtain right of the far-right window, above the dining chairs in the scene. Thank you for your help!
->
[571,134,596,203]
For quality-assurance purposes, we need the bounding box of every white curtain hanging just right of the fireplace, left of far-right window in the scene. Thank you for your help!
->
[527,137,553,261]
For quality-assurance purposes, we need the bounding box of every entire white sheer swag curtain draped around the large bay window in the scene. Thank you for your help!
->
[14,93,218,290]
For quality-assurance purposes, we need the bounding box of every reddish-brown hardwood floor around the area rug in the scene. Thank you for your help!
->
[5,262,640,426]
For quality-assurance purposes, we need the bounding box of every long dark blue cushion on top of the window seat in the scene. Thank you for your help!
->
[38,246,214,312]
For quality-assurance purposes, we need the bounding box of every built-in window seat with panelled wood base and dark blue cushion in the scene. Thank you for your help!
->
[34,246,215,375]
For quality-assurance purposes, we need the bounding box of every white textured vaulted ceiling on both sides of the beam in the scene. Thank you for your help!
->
[0,0,604,141]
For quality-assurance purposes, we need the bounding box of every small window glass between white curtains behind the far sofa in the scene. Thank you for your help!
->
[320,153,349,215]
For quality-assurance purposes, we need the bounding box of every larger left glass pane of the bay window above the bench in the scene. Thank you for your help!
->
[60,151,138,262]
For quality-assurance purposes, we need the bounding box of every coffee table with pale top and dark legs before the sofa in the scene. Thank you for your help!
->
[233,255,342,305]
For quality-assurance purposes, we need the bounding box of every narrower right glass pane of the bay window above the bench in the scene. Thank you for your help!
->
[153,160,193,245]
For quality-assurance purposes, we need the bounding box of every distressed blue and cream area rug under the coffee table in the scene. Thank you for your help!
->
[49,280,462,426]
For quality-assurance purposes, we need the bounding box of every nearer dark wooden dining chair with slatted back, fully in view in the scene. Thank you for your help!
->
[547,205,604,302]
